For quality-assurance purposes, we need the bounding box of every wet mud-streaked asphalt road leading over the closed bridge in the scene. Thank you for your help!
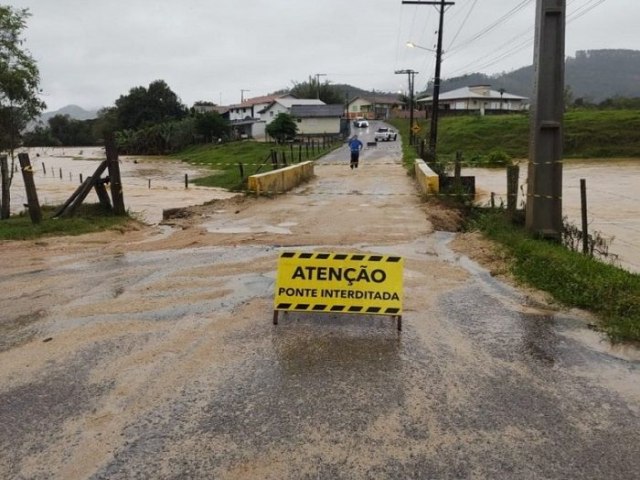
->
[0,124,640,479]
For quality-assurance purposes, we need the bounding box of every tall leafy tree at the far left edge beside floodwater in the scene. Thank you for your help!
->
[0,5,45,219]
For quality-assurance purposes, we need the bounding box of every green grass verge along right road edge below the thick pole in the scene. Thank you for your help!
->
[469,210,640,342]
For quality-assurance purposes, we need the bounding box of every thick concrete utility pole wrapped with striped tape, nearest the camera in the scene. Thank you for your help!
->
[525,0,566,240]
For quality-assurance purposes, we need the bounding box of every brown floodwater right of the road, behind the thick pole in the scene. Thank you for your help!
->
[463,159,640,272]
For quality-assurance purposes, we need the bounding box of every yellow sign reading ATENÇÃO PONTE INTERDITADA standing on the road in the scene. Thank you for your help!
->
[274,252,404,316]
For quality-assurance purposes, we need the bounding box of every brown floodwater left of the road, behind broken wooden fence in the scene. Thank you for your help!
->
[11,147,235,224]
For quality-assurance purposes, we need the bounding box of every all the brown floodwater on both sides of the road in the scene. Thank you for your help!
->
[6,147,640,272]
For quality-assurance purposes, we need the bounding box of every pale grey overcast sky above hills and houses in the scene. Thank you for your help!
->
[6,0,640,111]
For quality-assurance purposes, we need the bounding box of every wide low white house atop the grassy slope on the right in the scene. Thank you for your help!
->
[417,85,529,115]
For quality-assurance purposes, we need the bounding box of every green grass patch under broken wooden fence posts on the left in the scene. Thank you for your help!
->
[0,203,131,240]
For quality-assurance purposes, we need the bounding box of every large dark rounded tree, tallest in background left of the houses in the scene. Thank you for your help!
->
[115,80,187,130]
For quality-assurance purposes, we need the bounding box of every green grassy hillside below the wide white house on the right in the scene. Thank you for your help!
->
[396,110,640,159]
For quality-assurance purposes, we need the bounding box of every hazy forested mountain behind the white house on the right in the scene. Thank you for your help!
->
[422,49,640,103]
